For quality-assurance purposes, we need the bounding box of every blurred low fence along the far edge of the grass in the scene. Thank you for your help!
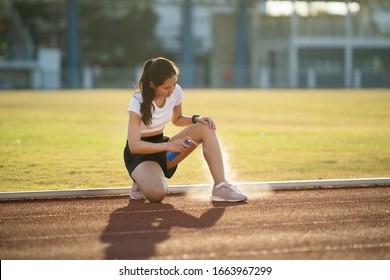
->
[0,62,390,89]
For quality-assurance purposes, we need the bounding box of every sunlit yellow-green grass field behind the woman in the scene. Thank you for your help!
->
[0,89,390,191]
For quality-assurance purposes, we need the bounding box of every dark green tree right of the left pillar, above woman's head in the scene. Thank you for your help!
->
[80,1,161,67]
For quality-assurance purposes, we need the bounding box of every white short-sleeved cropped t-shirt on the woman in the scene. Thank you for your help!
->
[127,84,184,134]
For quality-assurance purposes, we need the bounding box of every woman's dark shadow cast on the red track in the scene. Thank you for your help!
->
[101,197,241,259]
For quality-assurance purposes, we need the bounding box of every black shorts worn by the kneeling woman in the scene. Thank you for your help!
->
[123,133,177,179]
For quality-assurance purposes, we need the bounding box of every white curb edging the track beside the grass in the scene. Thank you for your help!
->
[0,178,390,200]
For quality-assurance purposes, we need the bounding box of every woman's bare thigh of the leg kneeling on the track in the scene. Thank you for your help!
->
[131,161,168,202]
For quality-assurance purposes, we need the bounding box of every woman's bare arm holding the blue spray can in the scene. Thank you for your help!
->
[127,112,188,154]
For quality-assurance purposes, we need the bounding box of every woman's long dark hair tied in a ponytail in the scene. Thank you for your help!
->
[138,57,179,125]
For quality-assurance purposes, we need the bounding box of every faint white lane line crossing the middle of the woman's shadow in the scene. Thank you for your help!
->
[0,218,390,242]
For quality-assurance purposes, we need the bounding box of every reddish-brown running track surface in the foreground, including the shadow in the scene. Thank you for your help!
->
[0,186,390,260]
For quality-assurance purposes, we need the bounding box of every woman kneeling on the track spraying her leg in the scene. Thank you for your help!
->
[124,57,247,202]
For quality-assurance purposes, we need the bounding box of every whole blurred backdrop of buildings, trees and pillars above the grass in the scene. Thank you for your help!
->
[0,0,390,89]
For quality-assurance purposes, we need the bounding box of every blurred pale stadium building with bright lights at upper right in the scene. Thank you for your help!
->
[210,0,390,88]
